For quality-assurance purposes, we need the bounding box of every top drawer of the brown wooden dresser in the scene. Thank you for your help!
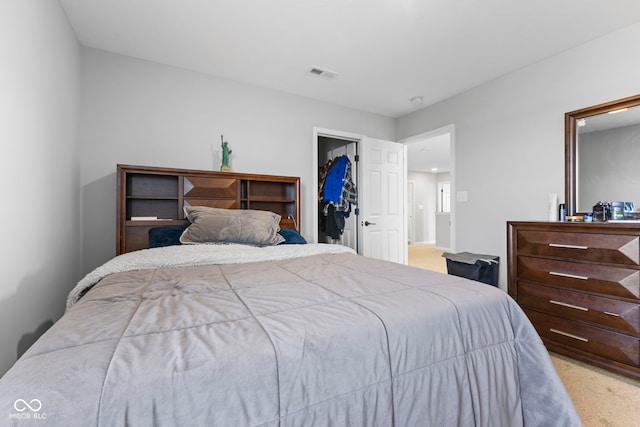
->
[516,230,640,265]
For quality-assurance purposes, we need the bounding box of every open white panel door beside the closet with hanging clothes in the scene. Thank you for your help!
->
[358,138,407,264]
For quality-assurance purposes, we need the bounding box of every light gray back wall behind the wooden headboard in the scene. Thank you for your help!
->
[80,49,395,272]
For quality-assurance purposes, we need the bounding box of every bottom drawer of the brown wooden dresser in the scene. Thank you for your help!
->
[524,309,640,367]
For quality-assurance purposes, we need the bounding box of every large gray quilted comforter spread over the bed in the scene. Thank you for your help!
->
[0,248,580,427]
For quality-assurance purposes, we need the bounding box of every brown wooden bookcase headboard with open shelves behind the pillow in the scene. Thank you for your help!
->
[116,165,300,255]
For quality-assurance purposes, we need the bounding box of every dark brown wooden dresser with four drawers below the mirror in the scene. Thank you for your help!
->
[507,221,640,379]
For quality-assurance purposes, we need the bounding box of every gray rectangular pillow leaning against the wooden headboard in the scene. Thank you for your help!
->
[180,206,285,246]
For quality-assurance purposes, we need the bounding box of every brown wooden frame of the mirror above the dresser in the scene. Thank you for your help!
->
[564,95,640,215]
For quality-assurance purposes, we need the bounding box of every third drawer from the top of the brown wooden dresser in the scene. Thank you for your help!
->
[518,282,640,337]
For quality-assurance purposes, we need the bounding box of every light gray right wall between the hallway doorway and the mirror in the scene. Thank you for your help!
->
[397,24,640,288]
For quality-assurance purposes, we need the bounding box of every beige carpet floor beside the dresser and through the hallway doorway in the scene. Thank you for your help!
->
[409,244,640,427]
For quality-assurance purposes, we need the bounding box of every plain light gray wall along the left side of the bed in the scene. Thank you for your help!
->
[0,0,80,375]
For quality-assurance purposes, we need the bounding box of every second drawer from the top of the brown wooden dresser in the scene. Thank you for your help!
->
[517,256,640,300]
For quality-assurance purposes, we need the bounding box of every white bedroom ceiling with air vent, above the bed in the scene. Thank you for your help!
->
[60,0,640,117]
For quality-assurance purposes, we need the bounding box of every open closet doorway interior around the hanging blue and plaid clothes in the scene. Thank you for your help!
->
[317,134,360,252]
